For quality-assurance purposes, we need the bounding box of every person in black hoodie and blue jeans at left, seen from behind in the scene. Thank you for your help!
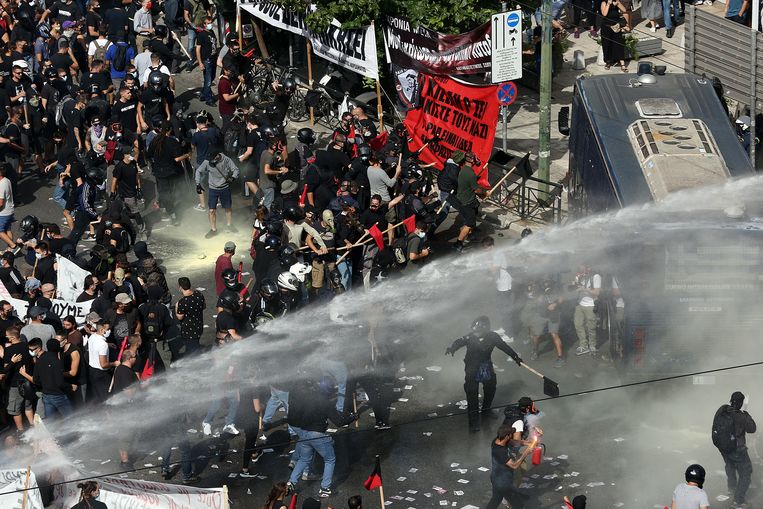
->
[33,338,75,420]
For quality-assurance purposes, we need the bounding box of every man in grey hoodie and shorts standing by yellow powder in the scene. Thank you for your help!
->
[196,147,239,239]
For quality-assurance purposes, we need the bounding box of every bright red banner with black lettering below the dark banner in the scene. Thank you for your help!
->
[405,74,500,186]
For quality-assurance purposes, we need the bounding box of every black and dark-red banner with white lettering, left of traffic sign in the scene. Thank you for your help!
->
[382,16,492,76]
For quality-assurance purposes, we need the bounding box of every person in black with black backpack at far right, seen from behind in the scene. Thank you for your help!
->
[713,391,757,506]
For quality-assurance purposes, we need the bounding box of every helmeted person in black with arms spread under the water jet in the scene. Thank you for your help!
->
[445,316,522,432]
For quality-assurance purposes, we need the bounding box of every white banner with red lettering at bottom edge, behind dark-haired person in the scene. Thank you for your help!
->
[54,472,229,509]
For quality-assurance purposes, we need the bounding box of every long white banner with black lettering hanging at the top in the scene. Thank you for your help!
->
[239,0,379,80]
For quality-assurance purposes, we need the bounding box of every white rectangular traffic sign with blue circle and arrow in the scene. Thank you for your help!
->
[491,11,522,83]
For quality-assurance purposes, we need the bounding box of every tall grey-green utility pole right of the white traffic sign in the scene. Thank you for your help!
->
[538,0,553,192]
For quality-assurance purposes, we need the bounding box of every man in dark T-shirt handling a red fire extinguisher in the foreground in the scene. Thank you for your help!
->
[485,424,533,509]
